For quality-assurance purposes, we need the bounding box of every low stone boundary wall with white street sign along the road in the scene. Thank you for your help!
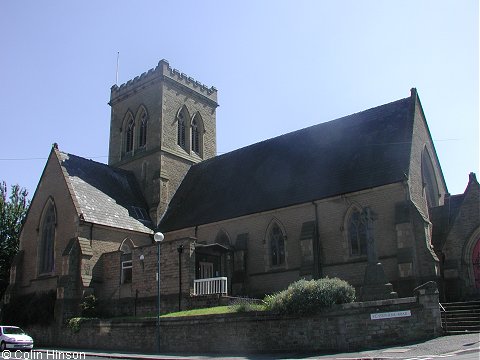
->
[28,289,442,354]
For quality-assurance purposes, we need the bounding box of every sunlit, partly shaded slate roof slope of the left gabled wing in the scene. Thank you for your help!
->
[55,150,152,233]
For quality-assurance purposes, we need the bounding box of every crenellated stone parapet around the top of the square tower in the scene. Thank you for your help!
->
[110,59,217,105]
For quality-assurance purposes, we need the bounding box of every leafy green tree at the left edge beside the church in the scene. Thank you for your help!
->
[0,181,30,297]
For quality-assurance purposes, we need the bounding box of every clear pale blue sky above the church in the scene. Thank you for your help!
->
[0,0,480,200]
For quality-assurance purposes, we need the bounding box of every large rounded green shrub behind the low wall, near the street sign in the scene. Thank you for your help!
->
[264,277,355,314]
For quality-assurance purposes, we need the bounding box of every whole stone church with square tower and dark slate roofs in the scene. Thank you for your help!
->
[4,60,480,319]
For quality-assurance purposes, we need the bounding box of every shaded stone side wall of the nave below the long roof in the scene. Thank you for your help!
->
[165,183,435,298]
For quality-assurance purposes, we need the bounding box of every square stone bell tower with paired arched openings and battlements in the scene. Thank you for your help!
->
[108,60,218,224]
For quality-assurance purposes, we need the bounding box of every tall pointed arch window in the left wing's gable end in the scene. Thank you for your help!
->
[38,200,57,274]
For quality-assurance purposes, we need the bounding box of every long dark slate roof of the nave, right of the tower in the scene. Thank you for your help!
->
[159,95,416,232]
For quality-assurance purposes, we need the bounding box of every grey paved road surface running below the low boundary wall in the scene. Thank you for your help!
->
[2,334,480,360]
